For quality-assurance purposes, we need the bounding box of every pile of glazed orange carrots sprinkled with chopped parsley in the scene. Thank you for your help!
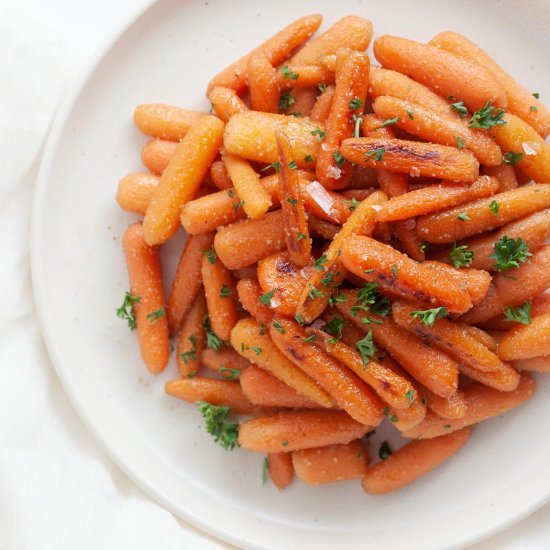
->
[117,15,550,494]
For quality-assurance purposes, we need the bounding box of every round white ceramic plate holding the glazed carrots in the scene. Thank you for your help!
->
[32,0,550,550]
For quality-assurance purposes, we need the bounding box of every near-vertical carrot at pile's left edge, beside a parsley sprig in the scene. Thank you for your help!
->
[122,223,170,374]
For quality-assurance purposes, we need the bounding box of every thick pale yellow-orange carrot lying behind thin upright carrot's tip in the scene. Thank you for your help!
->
[224,111,324,168]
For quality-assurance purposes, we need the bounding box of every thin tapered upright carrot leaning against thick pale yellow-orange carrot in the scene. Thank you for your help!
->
[275,131,311,267]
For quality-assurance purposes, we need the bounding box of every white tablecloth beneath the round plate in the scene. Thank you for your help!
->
[0,0,550,550]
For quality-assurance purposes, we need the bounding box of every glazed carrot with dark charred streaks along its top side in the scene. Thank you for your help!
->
[340,137,479,183]
